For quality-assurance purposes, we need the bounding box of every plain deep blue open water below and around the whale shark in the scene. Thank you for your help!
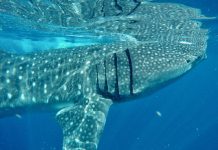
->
[0,0,218,150]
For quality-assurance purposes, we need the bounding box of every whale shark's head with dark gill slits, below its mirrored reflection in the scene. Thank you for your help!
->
[96,40,205,102]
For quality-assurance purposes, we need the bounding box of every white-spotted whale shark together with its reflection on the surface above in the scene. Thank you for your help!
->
[0,0,208,150]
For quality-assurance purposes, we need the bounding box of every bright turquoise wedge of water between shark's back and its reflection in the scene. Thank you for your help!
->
[0,14,134,53]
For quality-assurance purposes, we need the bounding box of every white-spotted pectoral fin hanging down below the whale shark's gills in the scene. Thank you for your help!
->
[56,97,111,150]
